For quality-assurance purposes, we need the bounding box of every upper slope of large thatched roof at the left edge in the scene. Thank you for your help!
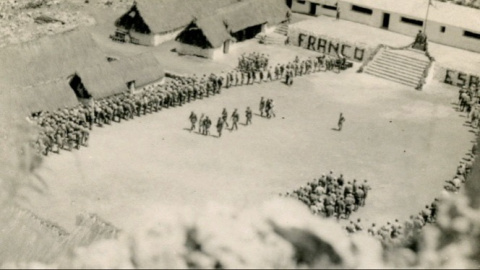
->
[0,30,106,88]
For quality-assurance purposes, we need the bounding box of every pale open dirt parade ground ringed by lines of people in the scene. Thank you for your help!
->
[24,62,474,230]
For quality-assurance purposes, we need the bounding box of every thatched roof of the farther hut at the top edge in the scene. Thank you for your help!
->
[115,0,239,34]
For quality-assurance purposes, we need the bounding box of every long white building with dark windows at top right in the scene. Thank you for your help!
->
[287,0,480,52]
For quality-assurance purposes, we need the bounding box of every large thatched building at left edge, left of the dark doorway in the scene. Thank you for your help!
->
[0,30,107,113]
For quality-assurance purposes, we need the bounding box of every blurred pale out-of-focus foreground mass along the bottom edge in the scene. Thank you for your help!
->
[4,190,480,269]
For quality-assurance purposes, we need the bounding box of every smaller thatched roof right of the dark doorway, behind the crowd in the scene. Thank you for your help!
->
[76,53,164,99]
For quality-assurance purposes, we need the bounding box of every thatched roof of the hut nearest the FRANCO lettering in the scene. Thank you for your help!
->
[176,0,288,48]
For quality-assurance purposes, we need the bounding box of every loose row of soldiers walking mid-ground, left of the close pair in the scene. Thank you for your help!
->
[188,107,253,138]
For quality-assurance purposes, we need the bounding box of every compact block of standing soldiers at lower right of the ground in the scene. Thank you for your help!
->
[285,172,371,219]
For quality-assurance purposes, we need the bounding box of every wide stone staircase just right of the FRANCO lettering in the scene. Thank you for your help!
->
[364,48,430,88]
